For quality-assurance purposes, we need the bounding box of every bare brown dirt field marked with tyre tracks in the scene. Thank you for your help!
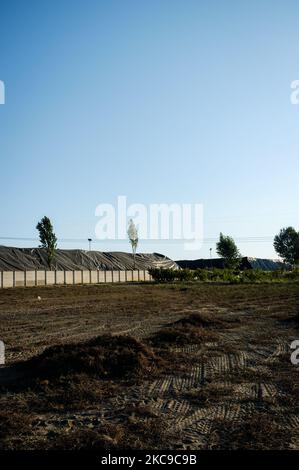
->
[0,283,299,449]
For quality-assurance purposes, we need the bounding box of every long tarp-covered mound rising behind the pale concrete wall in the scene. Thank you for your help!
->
[0,246,178,271]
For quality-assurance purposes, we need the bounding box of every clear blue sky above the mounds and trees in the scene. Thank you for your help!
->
[0,0,299,259]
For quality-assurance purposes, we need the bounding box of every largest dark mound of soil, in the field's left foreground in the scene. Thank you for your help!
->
[24,335,156,379]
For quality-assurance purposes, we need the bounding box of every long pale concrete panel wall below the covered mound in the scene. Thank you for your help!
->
[0,271,152,288]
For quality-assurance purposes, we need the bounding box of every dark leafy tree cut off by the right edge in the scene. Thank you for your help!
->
[274,227,299,266]
